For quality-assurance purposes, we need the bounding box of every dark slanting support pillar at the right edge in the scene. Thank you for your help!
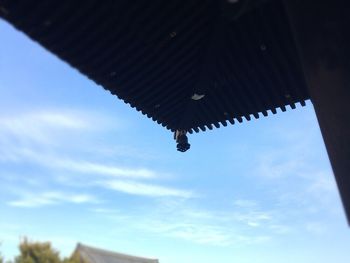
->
[284,0,350,224]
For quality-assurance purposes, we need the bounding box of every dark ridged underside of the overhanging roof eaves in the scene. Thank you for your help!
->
[0,0,309,132]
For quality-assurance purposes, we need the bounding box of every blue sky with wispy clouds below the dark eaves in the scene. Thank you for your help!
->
[0,21,350,263]
